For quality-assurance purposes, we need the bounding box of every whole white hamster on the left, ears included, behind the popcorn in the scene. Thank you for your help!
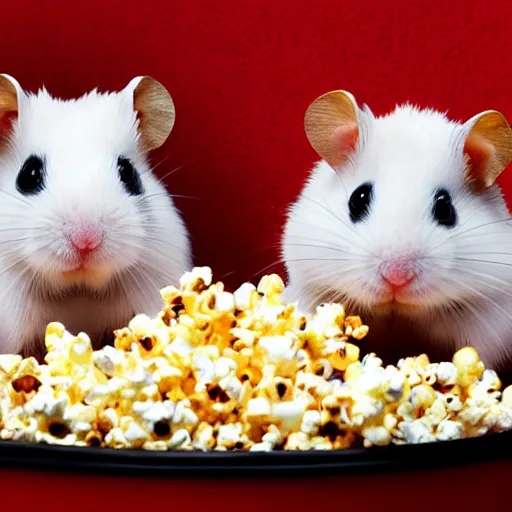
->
[0,75,192,355]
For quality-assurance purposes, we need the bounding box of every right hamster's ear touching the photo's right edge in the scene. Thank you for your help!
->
[464,110,512,188]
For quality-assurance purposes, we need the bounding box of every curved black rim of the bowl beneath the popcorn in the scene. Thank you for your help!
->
[0,430,512,478]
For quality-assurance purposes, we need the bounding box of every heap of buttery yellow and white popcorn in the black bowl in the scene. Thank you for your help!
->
[0,267,512,451]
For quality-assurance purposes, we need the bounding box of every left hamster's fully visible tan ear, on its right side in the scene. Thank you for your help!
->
[125,76,176,153]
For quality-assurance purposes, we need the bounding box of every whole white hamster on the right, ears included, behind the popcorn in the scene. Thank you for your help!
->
[282,91,512,369]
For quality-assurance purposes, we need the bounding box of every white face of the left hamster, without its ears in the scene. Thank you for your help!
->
[0,90,188,294]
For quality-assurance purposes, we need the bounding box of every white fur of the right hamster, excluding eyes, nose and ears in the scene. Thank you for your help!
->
[282,105,512,366]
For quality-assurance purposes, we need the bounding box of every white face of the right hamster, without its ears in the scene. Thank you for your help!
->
[282,106,512,316]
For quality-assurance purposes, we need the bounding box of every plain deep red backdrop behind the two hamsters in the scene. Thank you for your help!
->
[0,0,512,504]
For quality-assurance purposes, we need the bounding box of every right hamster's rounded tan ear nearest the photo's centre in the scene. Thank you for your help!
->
[304,90,359,168]
